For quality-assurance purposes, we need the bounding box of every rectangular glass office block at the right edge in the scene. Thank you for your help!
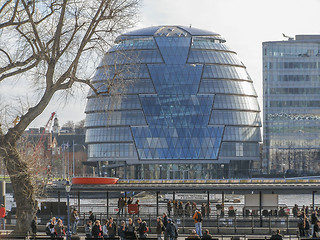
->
[263,35,320,175]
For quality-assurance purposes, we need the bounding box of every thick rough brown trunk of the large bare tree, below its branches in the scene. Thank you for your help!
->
[0,142,36,236]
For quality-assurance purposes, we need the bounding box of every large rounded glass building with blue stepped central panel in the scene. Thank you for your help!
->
[85,26,261,179]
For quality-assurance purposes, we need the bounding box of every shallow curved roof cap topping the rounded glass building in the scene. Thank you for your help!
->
[115,25,225,42]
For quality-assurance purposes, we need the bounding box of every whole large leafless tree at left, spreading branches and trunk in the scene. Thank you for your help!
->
[0,0,139,234]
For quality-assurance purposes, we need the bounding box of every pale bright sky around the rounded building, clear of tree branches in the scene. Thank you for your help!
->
[0,0,320,127]
